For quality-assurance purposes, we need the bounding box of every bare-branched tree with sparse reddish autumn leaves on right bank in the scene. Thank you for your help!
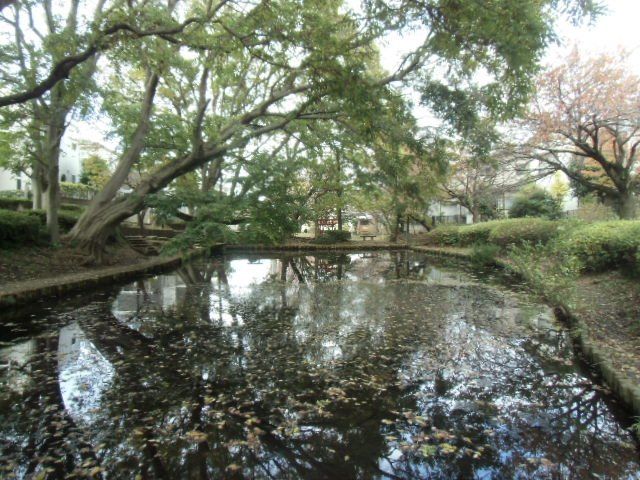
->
[517,49,640,218]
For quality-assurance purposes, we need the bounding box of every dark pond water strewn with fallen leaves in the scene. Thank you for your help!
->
[0,252,640,479]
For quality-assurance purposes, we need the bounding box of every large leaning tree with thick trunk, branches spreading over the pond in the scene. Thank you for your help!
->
[5,0,596,256]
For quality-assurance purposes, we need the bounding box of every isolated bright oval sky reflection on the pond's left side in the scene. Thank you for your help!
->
[58,323,114,423]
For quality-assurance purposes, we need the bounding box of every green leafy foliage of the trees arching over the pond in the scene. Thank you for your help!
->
[1,0,596,251]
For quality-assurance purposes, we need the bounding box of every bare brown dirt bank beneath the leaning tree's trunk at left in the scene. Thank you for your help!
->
[0,246,148,290]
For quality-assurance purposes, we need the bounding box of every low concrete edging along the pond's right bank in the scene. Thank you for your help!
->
[410,246,640,417]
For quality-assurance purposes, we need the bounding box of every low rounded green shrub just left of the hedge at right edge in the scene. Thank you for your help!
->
[489,218,559,248]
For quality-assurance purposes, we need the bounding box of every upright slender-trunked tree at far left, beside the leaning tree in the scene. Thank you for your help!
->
[0,0,104,242]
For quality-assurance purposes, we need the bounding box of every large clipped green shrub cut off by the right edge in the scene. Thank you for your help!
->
[560,220,640,272]
